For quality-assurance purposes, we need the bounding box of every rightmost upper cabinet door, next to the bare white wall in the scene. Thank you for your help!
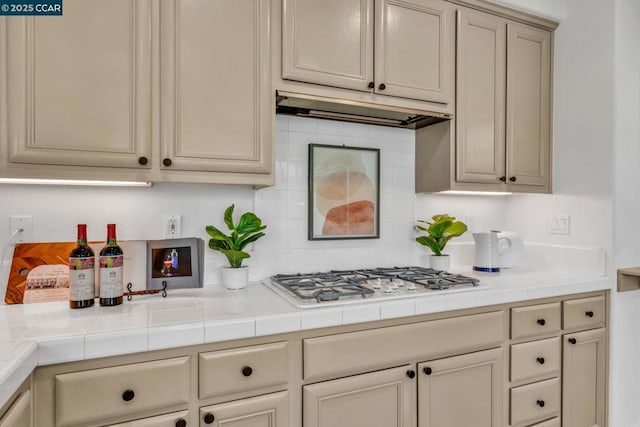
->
[507,22,551,186]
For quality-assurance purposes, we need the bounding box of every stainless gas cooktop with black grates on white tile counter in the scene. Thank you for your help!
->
[265,267,486,308]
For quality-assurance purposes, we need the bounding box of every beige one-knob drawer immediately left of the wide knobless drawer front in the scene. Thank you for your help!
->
[199,341,289,399]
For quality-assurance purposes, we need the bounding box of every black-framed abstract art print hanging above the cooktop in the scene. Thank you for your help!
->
[308,144,380,240]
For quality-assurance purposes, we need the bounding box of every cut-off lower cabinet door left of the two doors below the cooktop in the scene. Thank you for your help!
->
[200,391,289,427]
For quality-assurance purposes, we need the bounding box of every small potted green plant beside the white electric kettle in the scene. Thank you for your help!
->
[415,214,467,271]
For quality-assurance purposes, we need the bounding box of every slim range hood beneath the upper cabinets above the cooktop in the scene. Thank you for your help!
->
[276,91,451,129]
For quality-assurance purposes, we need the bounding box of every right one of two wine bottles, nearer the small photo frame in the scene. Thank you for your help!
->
[100,224,124,306]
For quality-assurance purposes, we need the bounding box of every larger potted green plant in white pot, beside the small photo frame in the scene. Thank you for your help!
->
[206,205,267,289]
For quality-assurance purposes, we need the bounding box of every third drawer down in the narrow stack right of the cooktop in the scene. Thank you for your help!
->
[511,378,560,425]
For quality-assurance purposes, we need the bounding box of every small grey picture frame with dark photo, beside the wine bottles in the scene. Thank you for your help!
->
[147,238,203,289]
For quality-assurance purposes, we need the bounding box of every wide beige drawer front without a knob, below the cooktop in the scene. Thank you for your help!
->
[303,311,504,379]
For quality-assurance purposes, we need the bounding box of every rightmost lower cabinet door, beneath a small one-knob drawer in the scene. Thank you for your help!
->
[562,329,607,427]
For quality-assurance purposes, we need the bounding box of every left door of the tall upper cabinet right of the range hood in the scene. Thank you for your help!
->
[456,8,507,184]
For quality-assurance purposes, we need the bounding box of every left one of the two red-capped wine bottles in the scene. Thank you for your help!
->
[69,224,96,308]
